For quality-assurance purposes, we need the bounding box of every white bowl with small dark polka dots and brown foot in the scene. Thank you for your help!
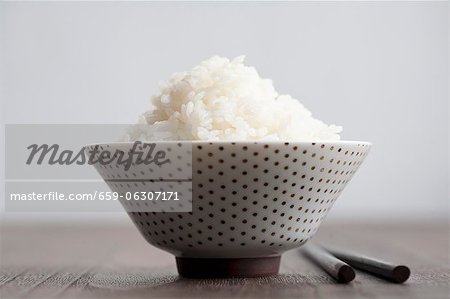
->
[86,141,370,277]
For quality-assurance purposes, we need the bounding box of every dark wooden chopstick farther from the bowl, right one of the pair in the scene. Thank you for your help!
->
[324,248,411,283]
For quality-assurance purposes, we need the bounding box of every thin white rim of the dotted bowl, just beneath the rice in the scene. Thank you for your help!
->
[84,140,372,147]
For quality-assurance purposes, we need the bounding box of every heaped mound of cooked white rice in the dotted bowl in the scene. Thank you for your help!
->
[126,56,342,141]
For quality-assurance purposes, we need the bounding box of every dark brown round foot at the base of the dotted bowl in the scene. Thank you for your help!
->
[176,256,281,278]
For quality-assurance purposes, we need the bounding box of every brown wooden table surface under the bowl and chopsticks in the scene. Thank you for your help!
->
[0,221,450,299]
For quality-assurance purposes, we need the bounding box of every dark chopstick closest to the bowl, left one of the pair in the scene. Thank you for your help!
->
[302,244,355,283]
